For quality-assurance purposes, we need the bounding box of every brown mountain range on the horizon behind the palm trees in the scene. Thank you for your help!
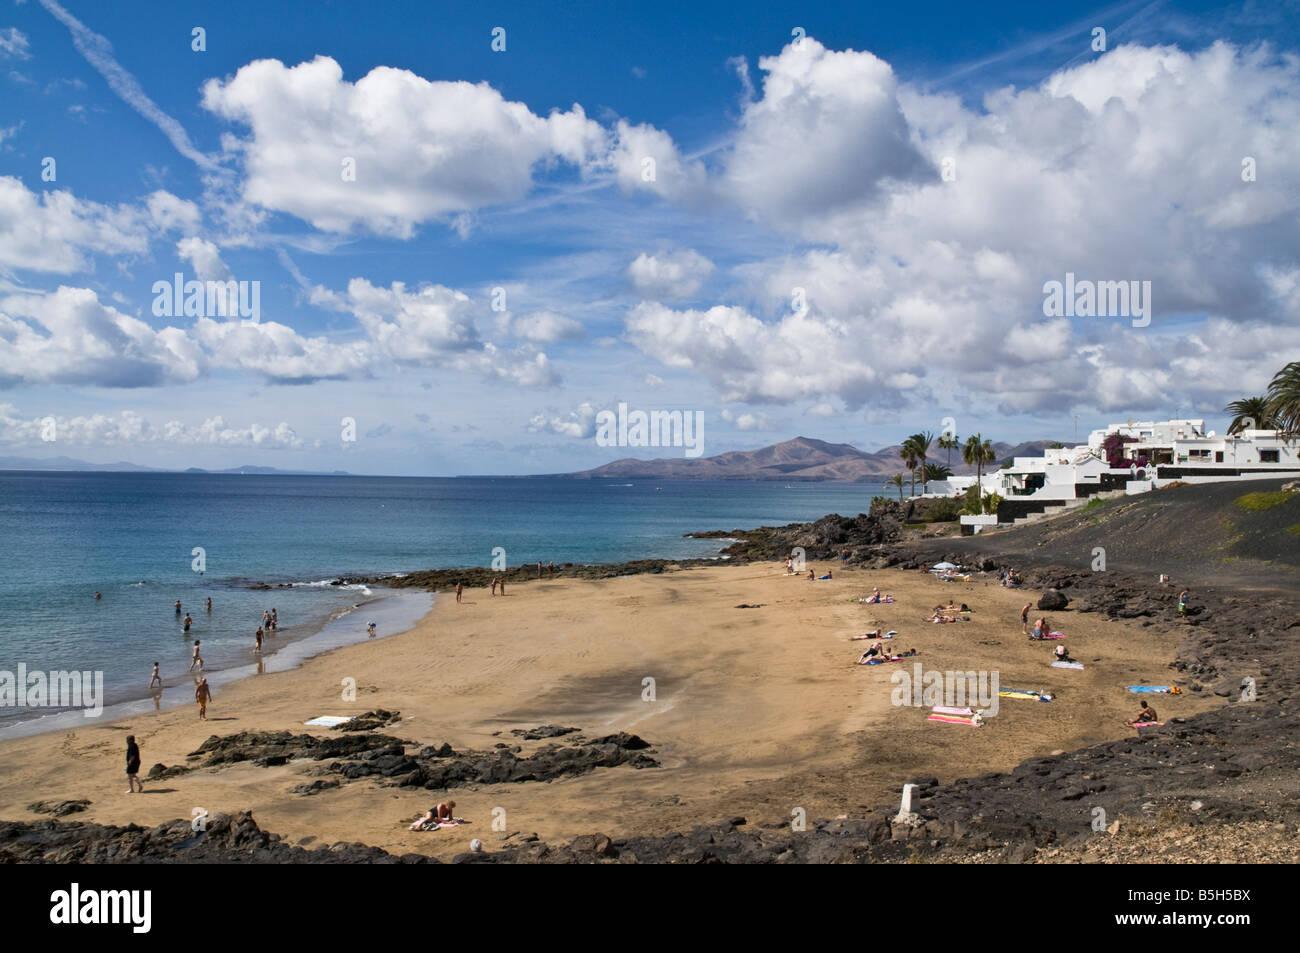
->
[556,437,1053,484]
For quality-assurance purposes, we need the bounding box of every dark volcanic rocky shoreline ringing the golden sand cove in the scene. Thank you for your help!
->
[0,491,1300,863]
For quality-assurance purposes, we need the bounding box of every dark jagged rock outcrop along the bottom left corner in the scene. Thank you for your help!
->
[0,811,437,863]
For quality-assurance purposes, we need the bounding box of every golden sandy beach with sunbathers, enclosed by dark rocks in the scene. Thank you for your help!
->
[0,563,1217,858]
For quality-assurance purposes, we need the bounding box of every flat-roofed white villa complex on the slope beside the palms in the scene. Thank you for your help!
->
[946,420,1300,533]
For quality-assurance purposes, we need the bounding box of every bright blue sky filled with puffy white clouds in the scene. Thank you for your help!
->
[0,0,1300,475]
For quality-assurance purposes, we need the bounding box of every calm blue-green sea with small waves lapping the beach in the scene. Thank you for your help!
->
[0,471,888,737]
